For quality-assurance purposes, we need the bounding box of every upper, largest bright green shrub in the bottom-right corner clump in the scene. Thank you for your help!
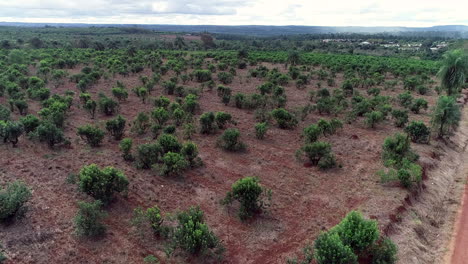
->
[333,211,379,253]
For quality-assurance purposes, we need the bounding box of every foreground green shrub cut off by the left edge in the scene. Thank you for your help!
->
[0,181,31,222]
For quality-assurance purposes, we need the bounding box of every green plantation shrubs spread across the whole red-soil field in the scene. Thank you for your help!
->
[0,48,466,263]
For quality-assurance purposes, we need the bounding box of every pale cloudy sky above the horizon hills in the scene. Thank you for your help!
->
[0,0,468,27]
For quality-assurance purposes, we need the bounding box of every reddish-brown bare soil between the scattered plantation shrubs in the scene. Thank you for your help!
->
[0,62,449,263]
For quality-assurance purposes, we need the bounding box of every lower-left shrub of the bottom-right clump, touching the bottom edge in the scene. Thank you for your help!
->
[314,232,358,264]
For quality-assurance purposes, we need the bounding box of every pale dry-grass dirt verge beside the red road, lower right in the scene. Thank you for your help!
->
[390,93,468,264]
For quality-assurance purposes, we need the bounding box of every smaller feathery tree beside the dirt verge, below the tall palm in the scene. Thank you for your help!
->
[431,96,461,138]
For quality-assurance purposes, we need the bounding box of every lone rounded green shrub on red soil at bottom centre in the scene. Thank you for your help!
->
[223,177,263,219]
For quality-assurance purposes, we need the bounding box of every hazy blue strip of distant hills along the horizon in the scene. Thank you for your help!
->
[0,22,468,36]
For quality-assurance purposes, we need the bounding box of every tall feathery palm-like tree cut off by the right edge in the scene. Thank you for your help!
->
[437,50,468,95]
